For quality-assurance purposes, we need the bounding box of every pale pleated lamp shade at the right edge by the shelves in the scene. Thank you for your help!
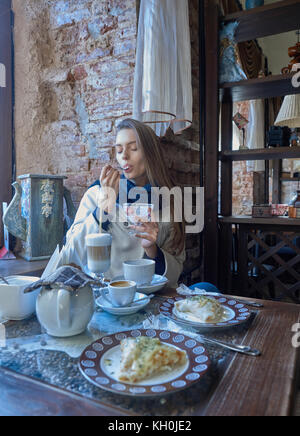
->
[275,94,300,129]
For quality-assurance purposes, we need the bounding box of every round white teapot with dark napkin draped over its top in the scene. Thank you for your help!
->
[36,285,94,338]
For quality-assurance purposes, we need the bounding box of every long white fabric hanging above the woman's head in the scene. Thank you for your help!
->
[133,0,193,136]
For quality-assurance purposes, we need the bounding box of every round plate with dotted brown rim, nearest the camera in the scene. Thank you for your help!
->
[79,329,210,397]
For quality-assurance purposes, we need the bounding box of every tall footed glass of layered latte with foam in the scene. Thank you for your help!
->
[85,233,112,298]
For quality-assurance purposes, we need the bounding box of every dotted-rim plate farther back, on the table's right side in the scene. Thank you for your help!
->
[159,295,251,331]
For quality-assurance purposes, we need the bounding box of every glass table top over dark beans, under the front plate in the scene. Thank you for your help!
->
[0,298,253,416]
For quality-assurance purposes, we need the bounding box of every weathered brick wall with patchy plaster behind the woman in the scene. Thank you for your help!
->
[13,0,200,282]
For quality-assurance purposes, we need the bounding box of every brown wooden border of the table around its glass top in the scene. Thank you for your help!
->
[0,289,300,416]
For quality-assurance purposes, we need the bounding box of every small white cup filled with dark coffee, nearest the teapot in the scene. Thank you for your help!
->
[102,280,136,307]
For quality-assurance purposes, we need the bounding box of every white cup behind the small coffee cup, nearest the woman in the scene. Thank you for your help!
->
[123,259,155,286]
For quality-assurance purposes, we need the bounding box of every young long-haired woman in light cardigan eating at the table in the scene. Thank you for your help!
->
[60,119,185,286]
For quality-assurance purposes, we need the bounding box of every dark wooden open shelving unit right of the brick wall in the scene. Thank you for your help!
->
[204,0,300,302]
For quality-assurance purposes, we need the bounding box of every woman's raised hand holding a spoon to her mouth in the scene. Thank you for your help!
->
[99,165,121,213]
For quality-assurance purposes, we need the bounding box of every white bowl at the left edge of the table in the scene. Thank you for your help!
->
[0,276,40,321]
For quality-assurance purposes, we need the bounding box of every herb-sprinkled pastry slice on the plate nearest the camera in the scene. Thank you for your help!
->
[119,336,187,383]
